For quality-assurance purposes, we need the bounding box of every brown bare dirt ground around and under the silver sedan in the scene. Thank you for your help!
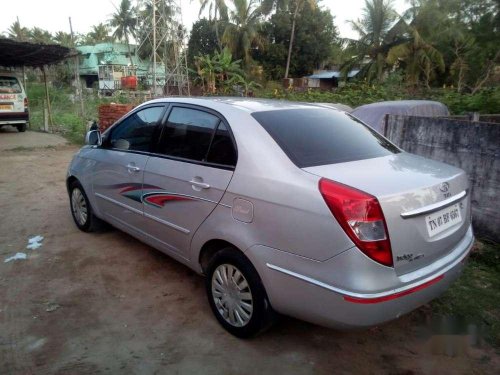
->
[0,138,500,375]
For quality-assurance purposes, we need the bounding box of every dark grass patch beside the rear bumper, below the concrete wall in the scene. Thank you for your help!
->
[431,242,500,347]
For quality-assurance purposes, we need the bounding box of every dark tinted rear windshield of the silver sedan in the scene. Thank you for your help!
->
[252,108,400,168]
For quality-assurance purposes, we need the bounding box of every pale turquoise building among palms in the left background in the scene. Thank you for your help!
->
[76,43,165,91]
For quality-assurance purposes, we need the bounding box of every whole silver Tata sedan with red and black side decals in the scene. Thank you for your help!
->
[67,98,474,337]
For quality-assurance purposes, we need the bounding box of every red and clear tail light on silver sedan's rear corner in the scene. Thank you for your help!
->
[319,178,393,267]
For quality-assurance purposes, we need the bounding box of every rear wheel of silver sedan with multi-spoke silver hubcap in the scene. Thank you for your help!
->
[205,247,276,338]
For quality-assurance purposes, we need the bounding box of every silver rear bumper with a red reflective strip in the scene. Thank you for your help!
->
[246,228,474,328]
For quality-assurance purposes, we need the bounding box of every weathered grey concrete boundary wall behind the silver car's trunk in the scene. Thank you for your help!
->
[384,115,500,242]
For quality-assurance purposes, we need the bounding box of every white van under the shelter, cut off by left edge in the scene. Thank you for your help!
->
[0,73,29,132]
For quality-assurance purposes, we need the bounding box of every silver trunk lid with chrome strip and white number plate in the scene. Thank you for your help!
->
[304,152,470,274]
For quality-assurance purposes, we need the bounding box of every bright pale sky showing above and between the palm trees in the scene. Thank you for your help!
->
[0,0,408,38]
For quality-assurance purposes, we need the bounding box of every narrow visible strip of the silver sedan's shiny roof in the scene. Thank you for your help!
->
[147,96,335,113]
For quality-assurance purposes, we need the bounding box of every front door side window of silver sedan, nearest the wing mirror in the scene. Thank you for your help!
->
[109,106,164,151]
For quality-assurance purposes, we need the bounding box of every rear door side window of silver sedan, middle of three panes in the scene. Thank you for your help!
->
[158,107,220,161]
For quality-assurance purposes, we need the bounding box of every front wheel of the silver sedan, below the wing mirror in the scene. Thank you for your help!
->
[69,180,104,232]
